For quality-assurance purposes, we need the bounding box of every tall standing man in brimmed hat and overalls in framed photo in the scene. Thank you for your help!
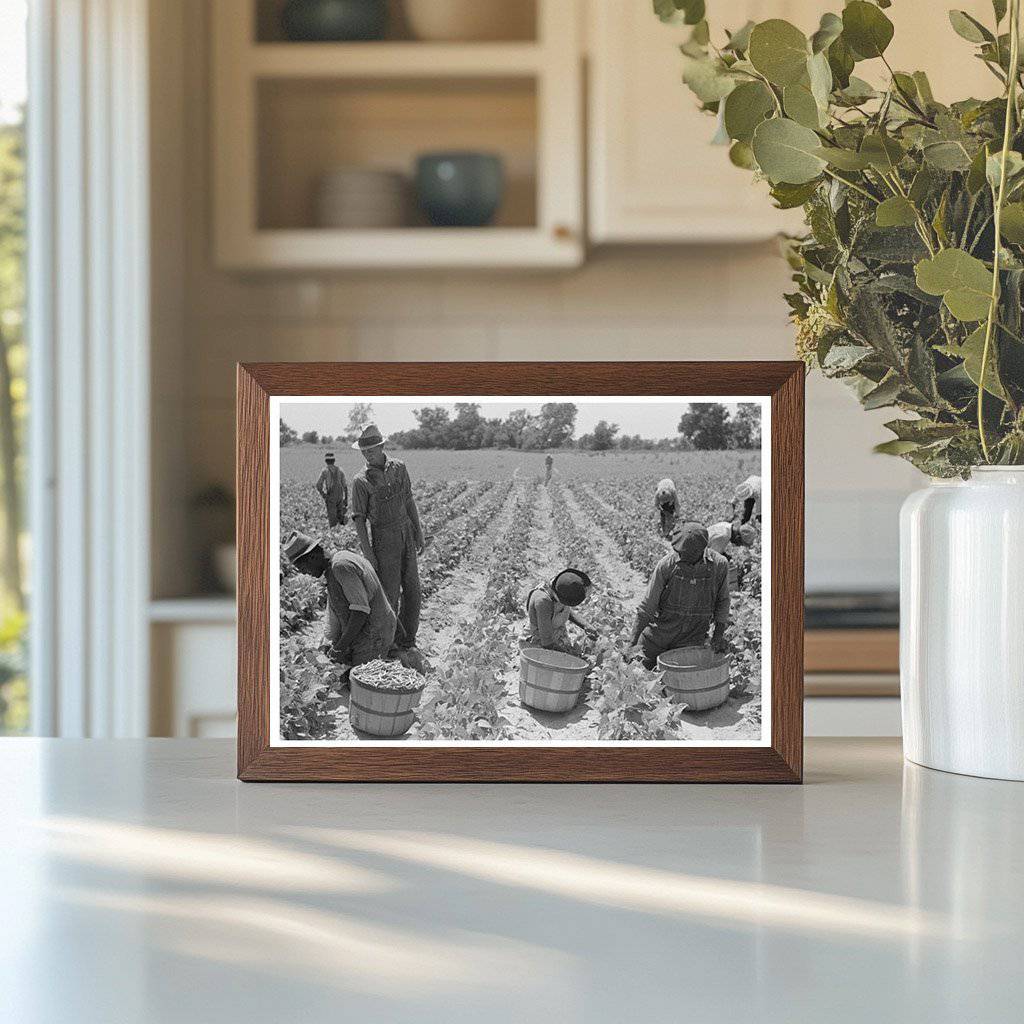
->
[352,423,424,648]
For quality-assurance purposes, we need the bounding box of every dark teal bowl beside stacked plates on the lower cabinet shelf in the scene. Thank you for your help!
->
[416,153,505,227]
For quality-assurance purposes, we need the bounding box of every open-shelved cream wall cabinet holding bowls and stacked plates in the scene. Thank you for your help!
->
[211,0,584,269]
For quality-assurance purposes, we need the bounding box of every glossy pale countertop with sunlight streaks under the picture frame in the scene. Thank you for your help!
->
[0,739,1024,1024]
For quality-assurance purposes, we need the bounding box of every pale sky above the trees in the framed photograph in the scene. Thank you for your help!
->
[281,397,757,438]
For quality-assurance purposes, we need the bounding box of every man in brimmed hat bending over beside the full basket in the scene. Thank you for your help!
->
[285,530,396,666]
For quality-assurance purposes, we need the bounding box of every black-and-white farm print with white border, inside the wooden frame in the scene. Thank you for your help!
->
[270,395,771,746]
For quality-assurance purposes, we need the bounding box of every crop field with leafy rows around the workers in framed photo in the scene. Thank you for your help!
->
[280,444,762,742]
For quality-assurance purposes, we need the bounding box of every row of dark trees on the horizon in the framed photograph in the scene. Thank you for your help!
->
[281,401,761,452]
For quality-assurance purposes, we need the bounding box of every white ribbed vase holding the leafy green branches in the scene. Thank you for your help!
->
[900,466,1024,781]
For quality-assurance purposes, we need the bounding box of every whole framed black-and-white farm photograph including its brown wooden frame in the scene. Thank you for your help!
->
[238,362,804,782]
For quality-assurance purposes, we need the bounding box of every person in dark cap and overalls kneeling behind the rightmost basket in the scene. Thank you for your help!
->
[632,522,729,670]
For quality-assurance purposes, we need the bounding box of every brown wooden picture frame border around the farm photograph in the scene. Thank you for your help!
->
[237,361,804,782]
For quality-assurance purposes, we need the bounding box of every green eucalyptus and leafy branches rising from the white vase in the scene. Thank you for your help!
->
[654,0,1024,477]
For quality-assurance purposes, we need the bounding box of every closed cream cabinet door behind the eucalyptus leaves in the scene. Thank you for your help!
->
[587,0,997,244]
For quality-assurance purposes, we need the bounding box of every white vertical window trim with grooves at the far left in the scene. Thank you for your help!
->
[28,0,150,736]
